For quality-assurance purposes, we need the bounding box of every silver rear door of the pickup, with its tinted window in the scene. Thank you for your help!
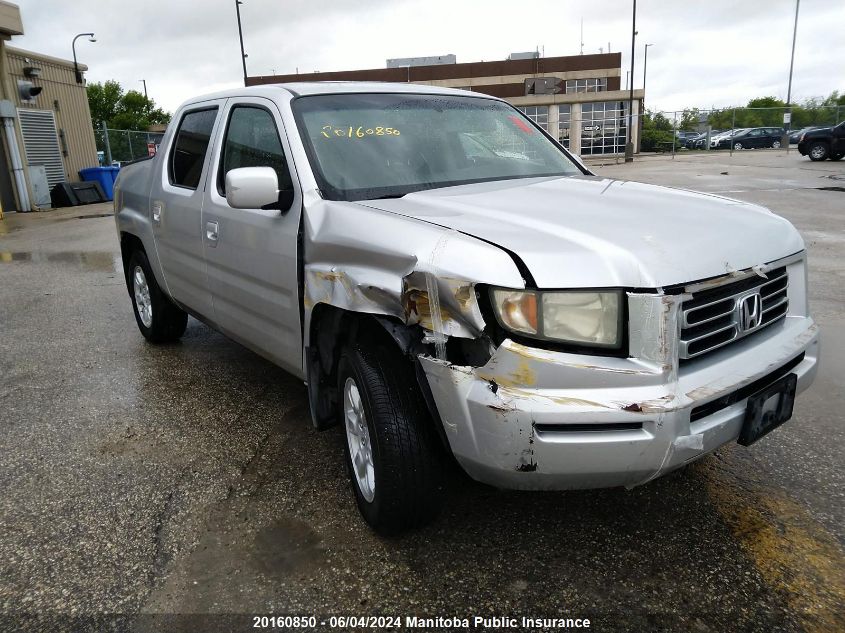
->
[151,105,225,321]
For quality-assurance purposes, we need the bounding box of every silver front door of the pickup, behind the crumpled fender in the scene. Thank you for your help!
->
[202,98,302,375]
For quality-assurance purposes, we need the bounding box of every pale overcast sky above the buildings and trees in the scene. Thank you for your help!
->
[11,0,845,111]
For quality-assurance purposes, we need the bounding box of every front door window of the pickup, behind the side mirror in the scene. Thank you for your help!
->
[217,106,293,195]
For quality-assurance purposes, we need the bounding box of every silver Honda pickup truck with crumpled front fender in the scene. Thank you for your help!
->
[115,83,819,533]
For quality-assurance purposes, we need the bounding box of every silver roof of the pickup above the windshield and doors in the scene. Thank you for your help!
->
[180,81,500,103]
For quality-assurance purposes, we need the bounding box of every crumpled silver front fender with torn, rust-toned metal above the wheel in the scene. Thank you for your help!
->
[304,196,525,342]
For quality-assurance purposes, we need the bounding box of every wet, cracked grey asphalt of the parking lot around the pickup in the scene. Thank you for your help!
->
[0,151,845,632]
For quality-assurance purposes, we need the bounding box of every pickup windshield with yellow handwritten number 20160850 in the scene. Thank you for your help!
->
[293,94,583,200]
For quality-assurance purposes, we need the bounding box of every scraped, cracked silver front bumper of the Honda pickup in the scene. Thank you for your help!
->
[420,295,819,490]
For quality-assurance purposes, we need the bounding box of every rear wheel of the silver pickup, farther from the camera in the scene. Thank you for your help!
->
[126,250,188,343]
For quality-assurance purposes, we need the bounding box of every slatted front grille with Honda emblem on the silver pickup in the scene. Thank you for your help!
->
[679,268,789,359]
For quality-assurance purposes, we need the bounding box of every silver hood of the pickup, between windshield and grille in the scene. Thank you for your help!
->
[359,176,804,288]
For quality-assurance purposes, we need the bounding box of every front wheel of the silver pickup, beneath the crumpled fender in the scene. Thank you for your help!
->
[338,343,444,536]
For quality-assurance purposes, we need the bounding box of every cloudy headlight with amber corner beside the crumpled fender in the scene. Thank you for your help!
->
[491,288,622,349]
